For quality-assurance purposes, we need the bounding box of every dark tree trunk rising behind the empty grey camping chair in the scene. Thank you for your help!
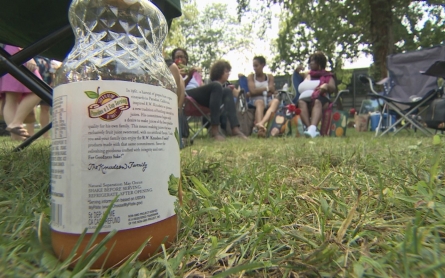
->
[368,0,394,78]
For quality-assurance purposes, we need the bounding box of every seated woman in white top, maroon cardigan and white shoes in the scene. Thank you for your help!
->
[296,51,335,138]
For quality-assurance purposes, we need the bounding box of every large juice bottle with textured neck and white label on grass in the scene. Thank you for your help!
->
[51,0,180,268]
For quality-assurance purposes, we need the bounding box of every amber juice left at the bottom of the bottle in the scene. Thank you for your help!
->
[51,215,178,269]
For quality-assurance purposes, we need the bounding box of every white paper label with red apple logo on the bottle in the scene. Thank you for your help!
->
[51,80,180,234]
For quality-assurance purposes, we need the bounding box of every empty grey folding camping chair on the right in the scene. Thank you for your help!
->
[359,45,445,136]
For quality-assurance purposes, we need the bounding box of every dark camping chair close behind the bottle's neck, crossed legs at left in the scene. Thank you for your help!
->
[0,0,181,151]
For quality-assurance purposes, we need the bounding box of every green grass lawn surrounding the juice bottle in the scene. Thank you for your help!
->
[0,130,445,277]
